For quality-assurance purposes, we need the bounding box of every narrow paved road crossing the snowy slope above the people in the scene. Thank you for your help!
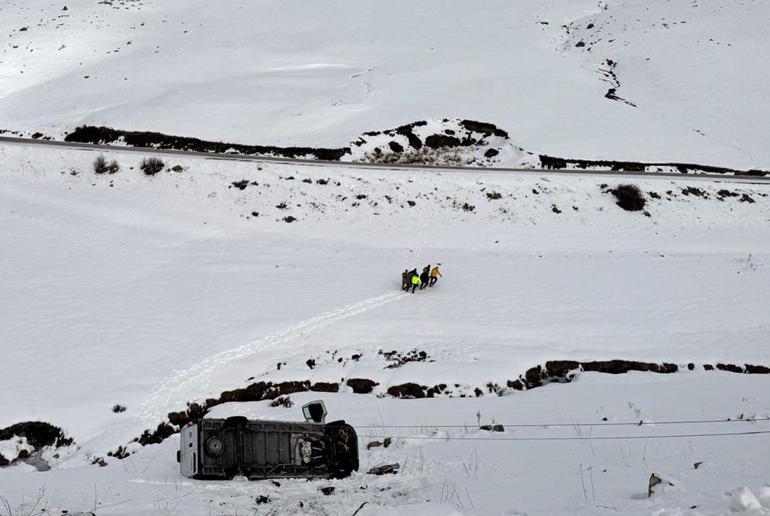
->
[0,136,770,184]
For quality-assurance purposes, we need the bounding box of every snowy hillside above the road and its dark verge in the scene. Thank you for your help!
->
[0,0,770,169]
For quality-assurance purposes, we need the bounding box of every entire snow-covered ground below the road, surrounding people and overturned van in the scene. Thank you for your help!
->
[0,145,770,515]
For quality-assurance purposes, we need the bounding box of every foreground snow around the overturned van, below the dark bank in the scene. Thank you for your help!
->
[0,372,770,516]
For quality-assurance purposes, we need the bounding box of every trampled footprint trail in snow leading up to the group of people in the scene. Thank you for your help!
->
[139,292,404,422]
